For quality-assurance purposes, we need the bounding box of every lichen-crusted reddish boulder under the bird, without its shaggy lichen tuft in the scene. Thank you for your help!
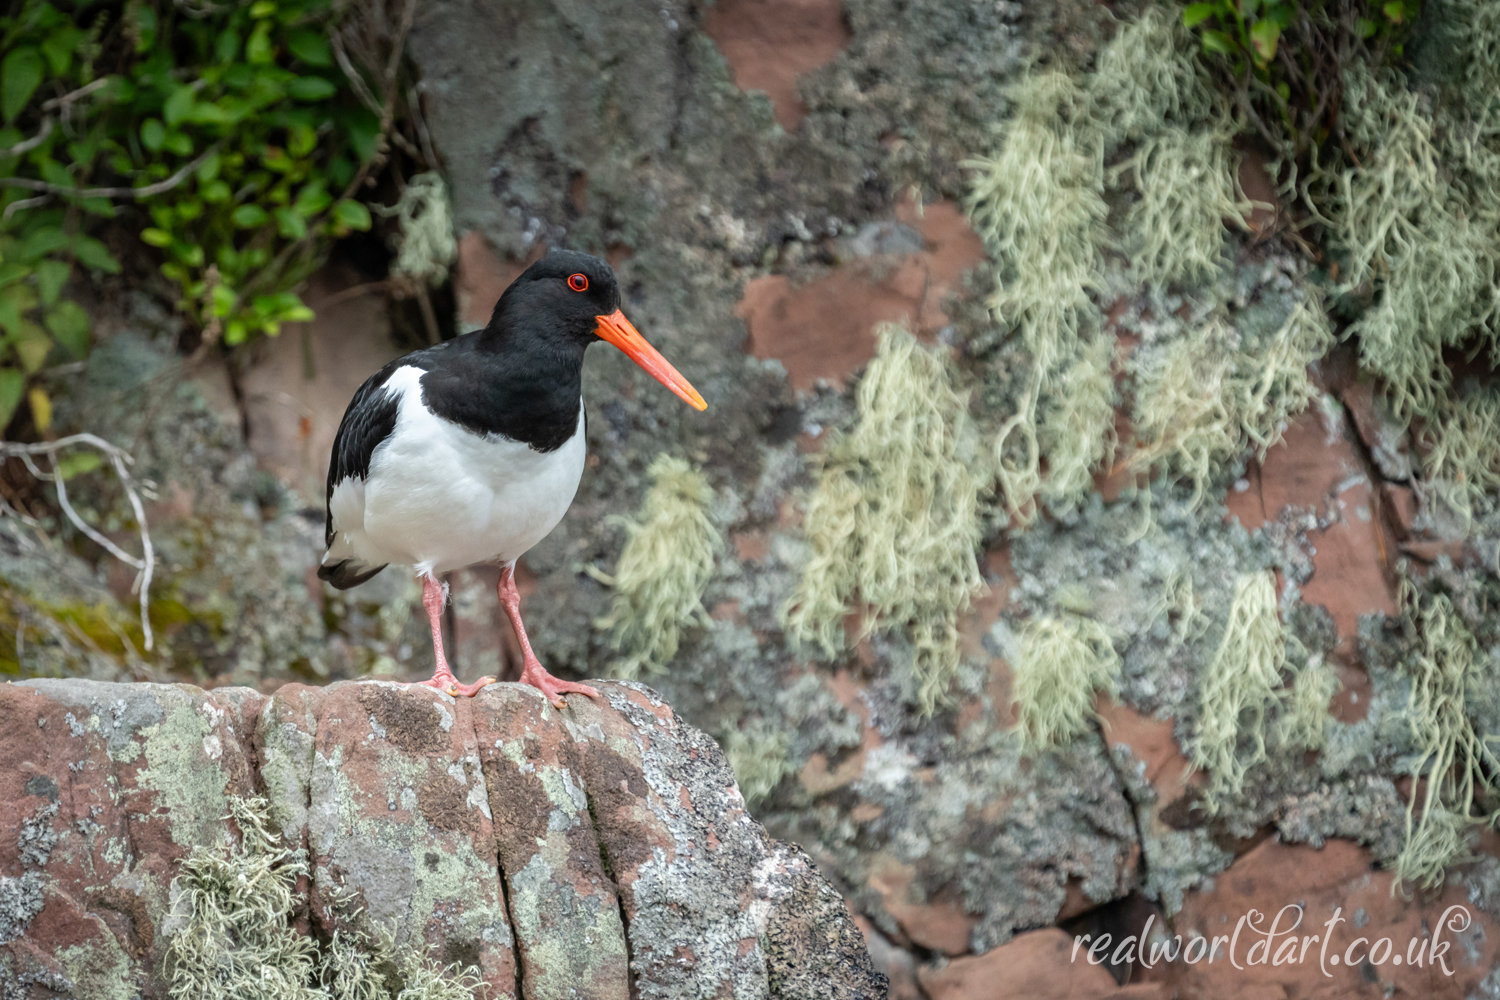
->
[0,681,885,1000]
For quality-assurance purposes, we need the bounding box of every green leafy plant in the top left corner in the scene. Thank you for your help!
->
[0,0,429,427]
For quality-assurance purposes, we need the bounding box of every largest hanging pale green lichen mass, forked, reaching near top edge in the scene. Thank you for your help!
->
[968,9,1250,523]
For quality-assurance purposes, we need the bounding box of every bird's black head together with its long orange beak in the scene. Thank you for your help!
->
[480,250,707,409]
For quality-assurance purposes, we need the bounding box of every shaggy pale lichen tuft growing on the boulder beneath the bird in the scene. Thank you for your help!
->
[162,798,479,1000]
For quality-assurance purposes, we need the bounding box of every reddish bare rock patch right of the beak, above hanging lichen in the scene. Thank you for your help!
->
[735,201,984,393]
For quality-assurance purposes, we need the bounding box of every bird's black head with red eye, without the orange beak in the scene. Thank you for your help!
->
[489,250,620,345]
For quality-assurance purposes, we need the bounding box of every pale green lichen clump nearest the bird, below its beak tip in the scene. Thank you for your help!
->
[597,454,722,679]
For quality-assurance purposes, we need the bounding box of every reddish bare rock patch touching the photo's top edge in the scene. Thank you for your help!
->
[702,0,849,132]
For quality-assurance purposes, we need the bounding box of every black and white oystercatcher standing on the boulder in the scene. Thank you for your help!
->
[318,250,707,706]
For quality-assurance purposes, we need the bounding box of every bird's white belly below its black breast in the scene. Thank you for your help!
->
[350,369,585,573]
